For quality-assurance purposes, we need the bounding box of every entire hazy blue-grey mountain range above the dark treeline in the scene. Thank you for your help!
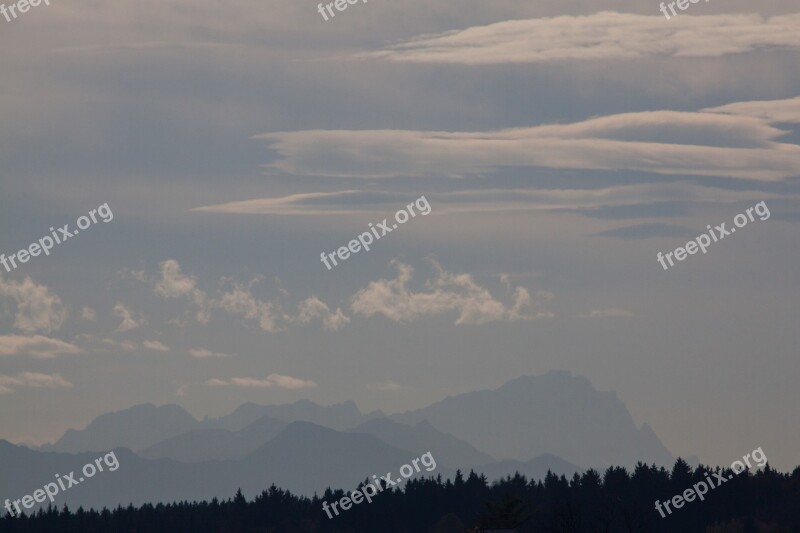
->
[0,372,674,507]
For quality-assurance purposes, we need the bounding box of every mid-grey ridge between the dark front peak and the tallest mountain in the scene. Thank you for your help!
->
[350,418,494,470]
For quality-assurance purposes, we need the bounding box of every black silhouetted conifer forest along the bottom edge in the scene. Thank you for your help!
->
[0,459,800,533]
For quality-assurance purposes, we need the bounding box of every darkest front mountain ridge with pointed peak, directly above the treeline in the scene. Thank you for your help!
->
[0,422,444,514]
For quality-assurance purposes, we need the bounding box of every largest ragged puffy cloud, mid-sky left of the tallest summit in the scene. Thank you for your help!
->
[351,261,552,325]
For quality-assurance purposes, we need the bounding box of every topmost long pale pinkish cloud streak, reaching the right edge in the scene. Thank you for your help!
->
[366,11,800,65]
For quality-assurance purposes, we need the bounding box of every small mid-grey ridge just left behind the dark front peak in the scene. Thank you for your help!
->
[137,416,288,463]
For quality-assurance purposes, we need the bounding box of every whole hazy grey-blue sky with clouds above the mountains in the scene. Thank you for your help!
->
[0,0,800,470]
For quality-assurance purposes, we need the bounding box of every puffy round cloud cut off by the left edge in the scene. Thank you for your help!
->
[0,276,67,333]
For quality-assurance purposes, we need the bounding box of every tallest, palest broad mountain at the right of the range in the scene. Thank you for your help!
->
[391,372,674,468]
